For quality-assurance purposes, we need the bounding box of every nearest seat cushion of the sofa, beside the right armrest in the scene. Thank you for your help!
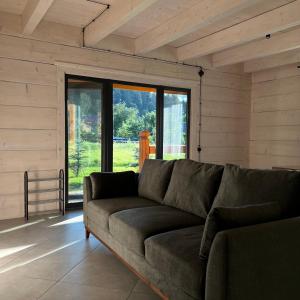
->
[145,226,205,299]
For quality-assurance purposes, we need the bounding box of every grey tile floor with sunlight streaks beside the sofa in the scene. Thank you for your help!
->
[0,212,159,300]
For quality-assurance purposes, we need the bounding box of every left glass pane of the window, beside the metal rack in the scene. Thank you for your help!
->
[67,79,102,203]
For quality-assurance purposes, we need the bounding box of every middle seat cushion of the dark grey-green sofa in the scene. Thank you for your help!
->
[109,206,205,255]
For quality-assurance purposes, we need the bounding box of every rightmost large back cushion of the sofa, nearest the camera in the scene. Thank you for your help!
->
[213,165,300,216]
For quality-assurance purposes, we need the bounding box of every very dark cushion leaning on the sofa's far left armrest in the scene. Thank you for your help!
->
[90,171,137,199]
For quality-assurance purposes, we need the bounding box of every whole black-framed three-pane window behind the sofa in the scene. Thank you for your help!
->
[66,75,190,207]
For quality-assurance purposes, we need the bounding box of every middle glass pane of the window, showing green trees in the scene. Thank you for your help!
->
[113,84,156,172]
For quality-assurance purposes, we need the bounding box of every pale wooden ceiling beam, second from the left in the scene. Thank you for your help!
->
[84,0,159,46]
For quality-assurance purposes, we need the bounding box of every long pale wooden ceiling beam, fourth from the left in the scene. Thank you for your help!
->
[177,0,300,61]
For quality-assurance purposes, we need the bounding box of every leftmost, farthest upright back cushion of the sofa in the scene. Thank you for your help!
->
[138,159,174,203]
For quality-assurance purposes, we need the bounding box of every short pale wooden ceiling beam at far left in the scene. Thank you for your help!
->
[22,0,54,35]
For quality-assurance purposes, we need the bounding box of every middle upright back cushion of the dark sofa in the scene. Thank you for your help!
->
[164,159,223,219]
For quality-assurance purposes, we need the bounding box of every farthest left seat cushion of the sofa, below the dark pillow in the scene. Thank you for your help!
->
[87,197,159,230]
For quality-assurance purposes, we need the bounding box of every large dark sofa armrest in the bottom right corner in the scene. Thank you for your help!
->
[205,217,300,300]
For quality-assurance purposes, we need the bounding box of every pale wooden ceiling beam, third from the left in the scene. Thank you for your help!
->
[135,0,259,54]
